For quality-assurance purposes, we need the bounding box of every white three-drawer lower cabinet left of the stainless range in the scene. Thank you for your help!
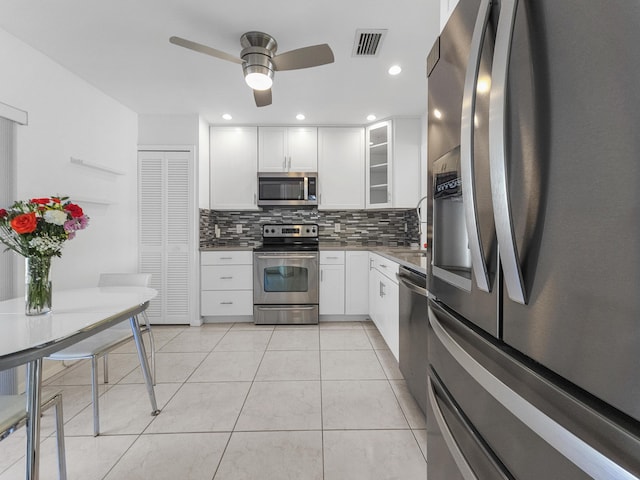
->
[200,251,253,317]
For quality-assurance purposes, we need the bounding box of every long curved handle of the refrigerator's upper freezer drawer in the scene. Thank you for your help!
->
[428,304,638,480]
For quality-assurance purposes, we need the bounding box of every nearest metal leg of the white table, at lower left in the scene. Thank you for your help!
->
[26,358,42,480]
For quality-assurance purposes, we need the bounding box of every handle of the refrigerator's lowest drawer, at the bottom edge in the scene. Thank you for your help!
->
[427,374,513,480]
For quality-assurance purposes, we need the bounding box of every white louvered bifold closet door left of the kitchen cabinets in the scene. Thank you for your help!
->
[138,151,196,324]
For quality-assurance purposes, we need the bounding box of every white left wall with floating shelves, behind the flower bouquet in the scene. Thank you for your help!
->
[0,29,138,290]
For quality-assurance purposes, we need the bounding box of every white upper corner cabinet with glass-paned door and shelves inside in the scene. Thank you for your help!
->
[366,117,422,208]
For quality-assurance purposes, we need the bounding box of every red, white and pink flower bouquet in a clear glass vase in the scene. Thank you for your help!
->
[0,197,89,315]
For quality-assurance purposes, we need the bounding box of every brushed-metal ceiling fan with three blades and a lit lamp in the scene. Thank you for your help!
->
[169,32,333,107]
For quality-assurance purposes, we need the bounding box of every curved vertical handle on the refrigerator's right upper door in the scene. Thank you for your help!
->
[489,0,527,305]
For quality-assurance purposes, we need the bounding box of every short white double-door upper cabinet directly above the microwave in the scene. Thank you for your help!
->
[258,127,318,172]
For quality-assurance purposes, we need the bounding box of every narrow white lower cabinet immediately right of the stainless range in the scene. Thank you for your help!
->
[320,250,345,315]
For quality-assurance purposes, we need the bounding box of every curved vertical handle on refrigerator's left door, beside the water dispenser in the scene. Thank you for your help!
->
[460,0,491,292]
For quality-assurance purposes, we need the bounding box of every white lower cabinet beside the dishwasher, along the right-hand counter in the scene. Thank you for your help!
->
[369,253,400,360]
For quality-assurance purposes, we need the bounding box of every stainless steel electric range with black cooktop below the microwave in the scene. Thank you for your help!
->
[253,224,319,325]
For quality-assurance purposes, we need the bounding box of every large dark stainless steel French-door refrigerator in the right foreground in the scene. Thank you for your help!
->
[427,0,640,480]
